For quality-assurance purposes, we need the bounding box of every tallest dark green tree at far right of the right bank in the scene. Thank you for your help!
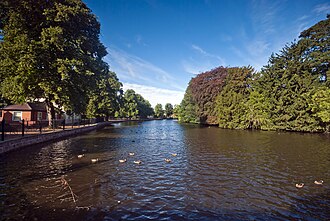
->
[254,16,330,131]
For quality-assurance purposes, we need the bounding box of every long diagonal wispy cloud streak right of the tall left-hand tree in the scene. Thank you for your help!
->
[104,46,183,90]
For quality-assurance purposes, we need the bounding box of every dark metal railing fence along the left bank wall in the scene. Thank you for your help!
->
[0,119,98,141]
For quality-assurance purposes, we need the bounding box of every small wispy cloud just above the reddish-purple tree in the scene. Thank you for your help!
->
[181,44,226,75]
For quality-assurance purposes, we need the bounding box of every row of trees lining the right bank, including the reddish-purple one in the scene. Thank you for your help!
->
[177,15,330,132]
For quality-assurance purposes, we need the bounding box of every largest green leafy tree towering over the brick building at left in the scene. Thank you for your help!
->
[0,0,108,125]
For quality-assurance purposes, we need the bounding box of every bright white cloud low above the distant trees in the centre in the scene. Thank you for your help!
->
[123,83,184,108]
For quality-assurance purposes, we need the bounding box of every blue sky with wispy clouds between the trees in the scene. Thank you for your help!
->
[84,0,330,106]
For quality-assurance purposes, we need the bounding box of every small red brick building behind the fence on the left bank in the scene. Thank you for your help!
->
[0,102,47,124]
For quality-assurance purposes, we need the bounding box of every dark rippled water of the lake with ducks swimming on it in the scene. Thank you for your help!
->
[0,120,330,220]
